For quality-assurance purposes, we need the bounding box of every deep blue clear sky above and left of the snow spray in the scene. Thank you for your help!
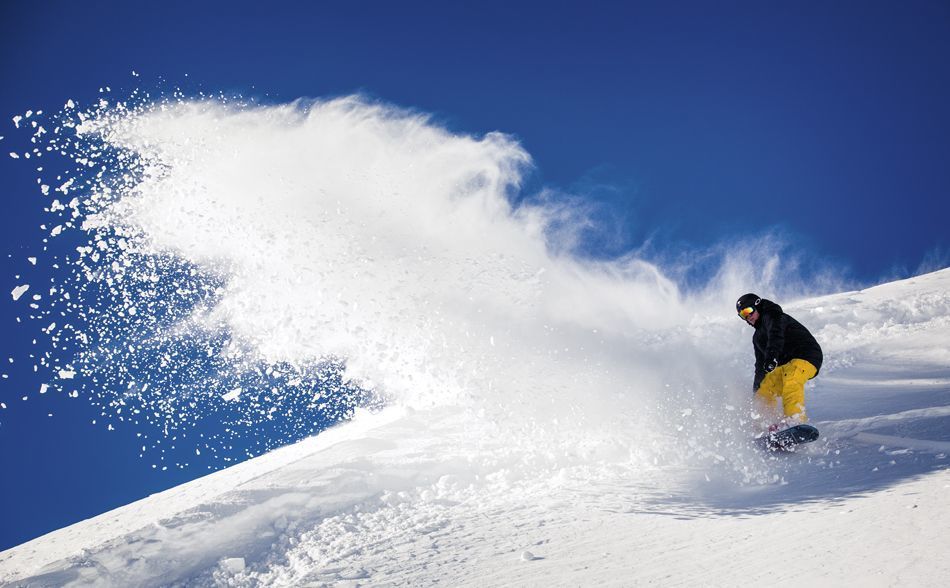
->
[0,1,950,548]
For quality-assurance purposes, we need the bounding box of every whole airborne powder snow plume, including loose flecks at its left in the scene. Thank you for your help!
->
[11,96,776,482]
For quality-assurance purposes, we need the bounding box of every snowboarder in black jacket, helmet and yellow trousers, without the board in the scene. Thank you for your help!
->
[736,293,822,431]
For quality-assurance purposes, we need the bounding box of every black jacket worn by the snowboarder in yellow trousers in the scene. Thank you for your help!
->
[752,298,822,390]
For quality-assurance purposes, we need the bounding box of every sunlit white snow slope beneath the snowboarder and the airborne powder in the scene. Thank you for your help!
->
[0,270,950,586]
